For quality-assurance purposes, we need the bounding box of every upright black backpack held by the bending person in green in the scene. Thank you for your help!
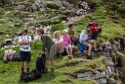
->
[36,54,46,73]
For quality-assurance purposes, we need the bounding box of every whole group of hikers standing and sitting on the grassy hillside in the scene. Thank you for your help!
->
[18,18,102,73]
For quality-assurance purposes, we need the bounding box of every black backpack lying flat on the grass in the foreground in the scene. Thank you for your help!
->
[21,69,41,82]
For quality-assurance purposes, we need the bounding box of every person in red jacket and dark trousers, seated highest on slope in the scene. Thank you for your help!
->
[87,18,102,40]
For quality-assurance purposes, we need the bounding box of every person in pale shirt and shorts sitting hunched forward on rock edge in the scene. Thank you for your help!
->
[79,28,97,59]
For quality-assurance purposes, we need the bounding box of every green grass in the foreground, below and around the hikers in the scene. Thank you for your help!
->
[0,42,106,84]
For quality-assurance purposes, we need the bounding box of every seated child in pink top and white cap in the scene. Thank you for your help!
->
[62,29,73,58]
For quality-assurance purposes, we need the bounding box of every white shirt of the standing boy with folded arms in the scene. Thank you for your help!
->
[18,35,32,52]
